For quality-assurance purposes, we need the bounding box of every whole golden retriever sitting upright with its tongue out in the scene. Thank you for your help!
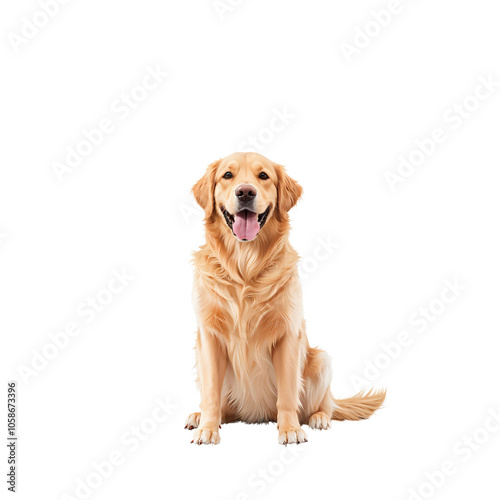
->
[186,153,385,445]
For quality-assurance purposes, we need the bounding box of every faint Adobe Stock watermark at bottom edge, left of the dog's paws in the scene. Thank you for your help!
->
[61,398,178,500]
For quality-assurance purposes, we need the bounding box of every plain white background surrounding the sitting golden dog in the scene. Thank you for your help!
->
[0,0,500,500]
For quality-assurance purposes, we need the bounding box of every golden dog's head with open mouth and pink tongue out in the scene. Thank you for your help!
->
[193,153,302,242]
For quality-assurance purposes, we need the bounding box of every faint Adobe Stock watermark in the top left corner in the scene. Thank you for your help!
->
[7,0,71,54]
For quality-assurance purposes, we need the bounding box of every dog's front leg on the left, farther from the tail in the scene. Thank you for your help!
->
[193,332,227,444]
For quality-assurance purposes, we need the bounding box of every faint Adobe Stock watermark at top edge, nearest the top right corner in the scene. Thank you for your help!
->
[340,0,413,64]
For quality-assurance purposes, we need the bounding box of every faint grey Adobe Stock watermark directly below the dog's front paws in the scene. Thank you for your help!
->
[230,446,307,500]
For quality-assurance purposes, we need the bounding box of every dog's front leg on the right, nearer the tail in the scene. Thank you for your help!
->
[273,335,307,444]
